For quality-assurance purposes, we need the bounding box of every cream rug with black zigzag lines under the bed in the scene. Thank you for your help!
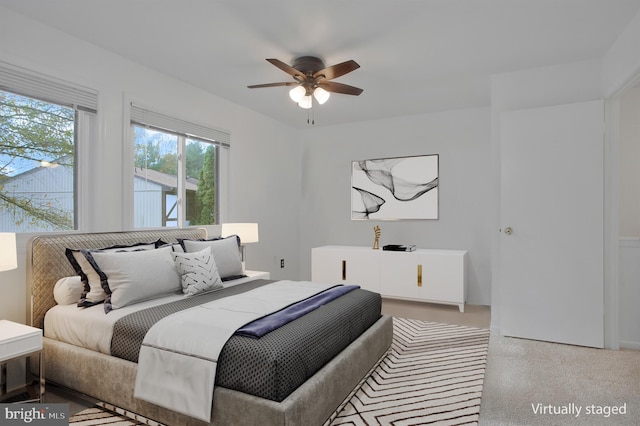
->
[70,318,489,426]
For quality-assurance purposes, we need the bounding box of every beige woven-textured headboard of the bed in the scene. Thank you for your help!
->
[27,228,207,328]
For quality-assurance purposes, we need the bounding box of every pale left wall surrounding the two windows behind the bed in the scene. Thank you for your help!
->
[0,7,300,322]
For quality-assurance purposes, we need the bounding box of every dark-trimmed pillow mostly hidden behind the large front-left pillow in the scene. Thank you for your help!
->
[65,243,156,307]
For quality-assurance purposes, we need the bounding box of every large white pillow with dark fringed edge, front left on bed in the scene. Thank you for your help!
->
[85,247,182,313]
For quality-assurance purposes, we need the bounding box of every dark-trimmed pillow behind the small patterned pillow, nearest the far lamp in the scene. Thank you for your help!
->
[180,235,244,281]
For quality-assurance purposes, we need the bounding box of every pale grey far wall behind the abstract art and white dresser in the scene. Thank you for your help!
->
[300,108,491,305]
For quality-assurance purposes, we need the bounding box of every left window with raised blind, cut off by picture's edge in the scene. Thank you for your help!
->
[0,62,97,232]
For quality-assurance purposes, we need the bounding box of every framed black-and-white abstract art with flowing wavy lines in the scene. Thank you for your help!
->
[351,154,439,220]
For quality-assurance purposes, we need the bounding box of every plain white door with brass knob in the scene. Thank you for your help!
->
[499,101,604,347]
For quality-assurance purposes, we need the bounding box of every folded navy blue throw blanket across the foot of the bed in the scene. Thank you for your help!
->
[235,285,360,339]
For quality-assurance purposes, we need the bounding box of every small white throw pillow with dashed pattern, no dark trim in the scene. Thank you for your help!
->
[171,247,222,296]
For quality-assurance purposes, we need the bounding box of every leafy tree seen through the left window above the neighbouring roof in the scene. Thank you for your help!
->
[0,91,75,229]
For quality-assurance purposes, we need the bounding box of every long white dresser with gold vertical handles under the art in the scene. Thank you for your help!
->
[311,246,467,312]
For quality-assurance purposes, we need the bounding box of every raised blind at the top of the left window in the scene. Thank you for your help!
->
[0,61,98,113]
